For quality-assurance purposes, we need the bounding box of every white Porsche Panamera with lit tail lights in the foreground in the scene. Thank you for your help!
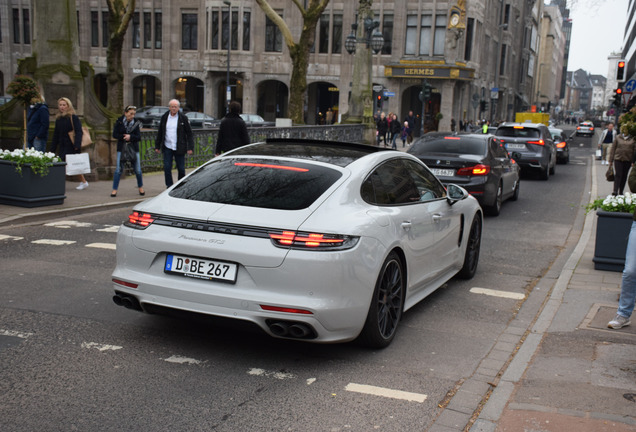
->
[112,140,483,348]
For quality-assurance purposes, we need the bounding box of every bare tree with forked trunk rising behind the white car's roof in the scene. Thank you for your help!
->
[256,0,329,124]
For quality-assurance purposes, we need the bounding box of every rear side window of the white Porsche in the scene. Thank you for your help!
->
[360,159,420,205]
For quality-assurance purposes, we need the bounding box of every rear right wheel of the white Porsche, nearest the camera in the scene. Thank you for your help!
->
[358,252,406,348]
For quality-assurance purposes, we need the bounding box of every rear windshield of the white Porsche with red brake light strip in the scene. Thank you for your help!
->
[170,158,342,210]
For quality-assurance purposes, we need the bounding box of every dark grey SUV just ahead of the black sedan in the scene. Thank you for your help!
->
[495,123,556,180]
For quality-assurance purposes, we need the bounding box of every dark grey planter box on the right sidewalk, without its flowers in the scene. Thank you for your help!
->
[594,210,634,272]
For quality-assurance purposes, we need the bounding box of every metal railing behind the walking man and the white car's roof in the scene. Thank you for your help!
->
[139,124,364,172]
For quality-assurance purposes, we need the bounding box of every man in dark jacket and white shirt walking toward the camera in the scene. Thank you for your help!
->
[155,99,194,187]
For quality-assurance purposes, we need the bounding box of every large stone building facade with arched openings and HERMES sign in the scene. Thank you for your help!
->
[0,0,563,130]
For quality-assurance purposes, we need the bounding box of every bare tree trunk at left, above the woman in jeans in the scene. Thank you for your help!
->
[106,0,135,112]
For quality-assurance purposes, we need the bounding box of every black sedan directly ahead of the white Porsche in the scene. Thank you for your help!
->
[408,132,520,216]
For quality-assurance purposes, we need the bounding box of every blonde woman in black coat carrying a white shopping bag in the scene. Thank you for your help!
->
[51,97,88,190]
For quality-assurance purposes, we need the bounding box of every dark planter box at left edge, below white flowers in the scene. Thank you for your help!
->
[0,160,66,208]
